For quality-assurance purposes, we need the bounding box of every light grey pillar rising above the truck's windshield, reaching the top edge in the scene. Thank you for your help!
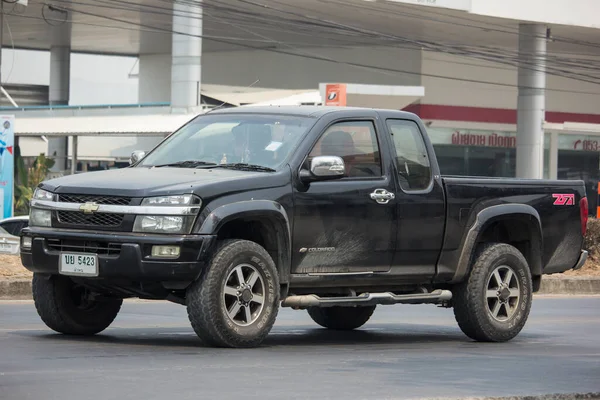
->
[171,0,202,111]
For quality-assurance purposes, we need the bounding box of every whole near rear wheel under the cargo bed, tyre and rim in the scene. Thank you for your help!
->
[452,243,533,342]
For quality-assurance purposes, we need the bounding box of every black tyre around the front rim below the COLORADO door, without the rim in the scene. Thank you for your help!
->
[186,239,280,348]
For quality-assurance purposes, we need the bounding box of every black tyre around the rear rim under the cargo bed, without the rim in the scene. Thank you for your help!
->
[452,243,533,342]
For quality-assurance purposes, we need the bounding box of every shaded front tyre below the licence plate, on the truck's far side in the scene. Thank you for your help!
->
[32,273,123,335]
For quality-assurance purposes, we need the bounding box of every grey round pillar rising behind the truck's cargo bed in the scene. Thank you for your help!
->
[517,24,546,179]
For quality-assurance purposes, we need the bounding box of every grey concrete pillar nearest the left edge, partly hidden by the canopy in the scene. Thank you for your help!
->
[48,46,71,172]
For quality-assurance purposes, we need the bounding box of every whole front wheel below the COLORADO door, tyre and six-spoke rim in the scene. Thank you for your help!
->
[186,240,279,347]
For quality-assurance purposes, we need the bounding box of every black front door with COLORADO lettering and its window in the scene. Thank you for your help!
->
[292,118,397,274]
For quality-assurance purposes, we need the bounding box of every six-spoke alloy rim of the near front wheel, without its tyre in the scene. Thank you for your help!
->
[223,264,265,326]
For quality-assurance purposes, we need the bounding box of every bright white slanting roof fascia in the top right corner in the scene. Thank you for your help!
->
[471,0,600,28]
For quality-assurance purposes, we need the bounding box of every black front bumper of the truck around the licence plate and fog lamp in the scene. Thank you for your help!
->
[21,227,215,282]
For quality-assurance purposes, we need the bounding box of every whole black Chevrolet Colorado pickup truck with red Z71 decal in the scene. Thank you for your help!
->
[21,106,588,347]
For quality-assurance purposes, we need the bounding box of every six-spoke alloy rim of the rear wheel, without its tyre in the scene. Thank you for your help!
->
[485,265,521,322]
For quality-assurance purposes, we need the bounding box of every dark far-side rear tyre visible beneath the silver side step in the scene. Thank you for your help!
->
[307,306,376,331]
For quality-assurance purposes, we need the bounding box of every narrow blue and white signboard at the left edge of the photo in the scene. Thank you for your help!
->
[0,115,15,219]
